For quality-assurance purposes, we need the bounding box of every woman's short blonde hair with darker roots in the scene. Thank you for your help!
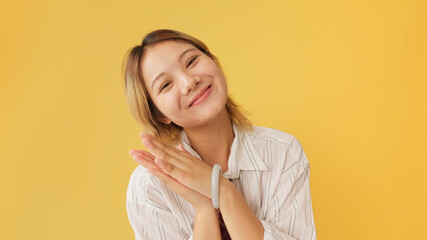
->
[122,29,252,144]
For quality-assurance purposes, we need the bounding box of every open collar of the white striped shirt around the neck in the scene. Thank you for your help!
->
[180,124,268,179]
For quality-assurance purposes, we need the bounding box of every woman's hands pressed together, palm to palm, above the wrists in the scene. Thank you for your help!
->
[129,132,212,208]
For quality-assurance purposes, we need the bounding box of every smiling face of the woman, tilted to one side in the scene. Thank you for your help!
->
[141,41,228,128]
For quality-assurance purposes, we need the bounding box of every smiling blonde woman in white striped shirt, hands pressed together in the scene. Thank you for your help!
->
[124,30,316,240]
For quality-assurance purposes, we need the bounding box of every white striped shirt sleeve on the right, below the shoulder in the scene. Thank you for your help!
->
[261,139,316,240]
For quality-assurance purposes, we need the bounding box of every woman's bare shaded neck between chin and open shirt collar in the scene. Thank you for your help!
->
[184,108,234,172]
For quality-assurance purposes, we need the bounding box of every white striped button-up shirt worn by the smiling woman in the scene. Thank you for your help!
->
[126,126,316,240]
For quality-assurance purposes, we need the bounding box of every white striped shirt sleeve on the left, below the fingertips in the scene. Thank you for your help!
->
[126,167,192,240]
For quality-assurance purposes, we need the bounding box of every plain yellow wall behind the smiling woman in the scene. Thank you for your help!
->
[0,0,427,239]
